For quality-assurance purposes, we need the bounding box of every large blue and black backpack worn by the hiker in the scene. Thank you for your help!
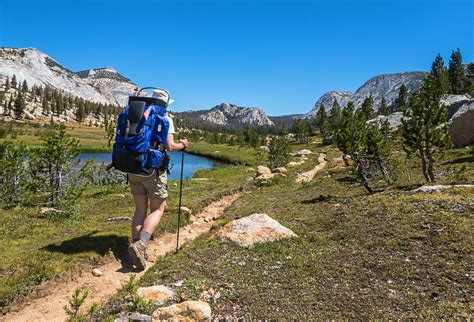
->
[111,96,169,174]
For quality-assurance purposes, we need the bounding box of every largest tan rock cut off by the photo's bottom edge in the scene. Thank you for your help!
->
[153,301,212,321]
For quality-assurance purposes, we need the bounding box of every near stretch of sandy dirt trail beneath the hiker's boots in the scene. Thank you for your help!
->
[0,193,241,322]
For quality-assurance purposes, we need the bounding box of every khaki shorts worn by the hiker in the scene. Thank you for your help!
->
[128,169,168,199]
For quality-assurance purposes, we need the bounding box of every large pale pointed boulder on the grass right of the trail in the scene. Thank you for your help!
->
[216,214,297,248]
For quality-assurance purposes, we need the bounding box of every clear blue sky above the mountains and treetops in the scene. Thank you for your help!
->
[0,0,474,115]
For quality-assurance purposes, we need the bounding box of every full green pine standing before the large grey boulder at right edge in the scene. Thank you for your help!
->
[402,81,450,182]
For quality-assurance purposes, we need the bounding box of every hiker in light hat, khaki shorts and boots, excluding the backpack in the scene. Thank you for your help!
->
[128,89,188,270]
